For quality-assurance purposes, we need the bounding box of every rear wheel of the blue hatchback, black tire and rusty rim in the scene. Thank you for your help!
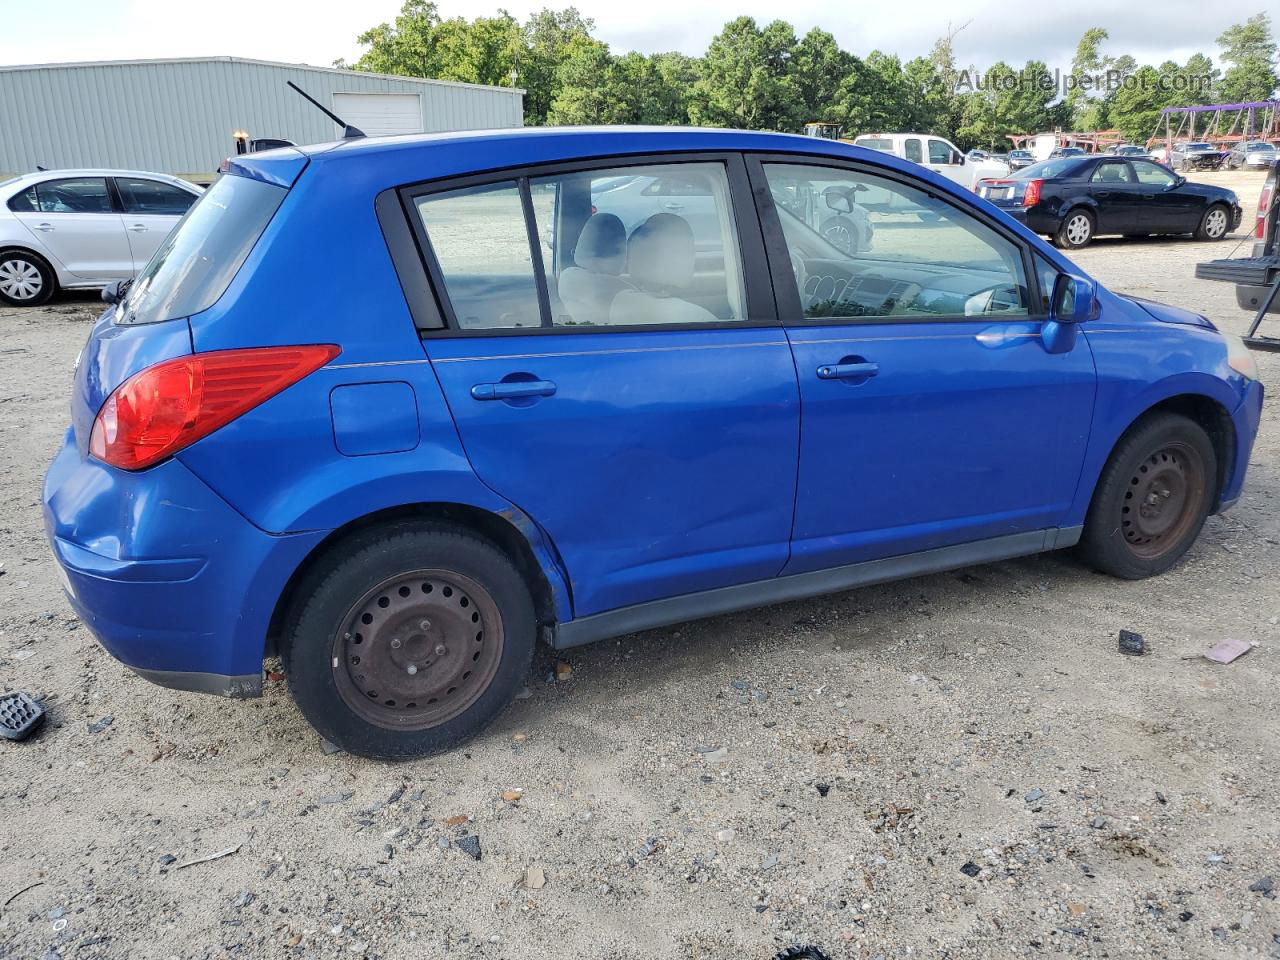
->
[282,521,538,760]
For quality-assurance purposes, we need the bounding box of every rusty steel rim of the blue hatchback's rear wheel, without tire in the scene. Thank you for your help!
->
[333,570,503,730]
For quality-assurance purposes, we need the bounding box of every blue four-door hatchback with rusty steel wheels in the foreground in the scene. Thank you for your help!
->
[45,128,1262,758]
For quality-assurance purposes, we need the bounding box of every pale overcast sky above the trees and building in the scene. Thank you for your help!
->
[0,0,1263,69]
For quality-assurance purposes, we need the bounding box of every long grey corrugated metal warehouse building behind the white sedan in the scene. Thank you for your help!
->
[0,56,524,180]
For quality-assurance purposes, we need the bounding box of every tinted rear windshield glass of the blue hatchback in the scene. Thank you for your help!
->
[116,175,287,324]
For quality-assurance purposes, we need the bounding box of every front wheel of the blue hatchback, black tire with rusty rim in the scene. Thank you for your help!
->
[1078,413,1217,580]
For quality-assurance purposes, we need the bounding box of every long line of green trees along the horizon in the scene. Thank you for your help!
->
[337,0,1280,148]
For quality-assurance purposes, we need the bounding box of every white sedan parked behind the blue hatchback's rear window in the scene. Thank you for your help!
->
[0,170,201,306]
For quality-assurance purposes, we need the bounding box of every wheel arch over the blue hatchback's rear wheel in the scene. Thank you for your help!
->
[264,502,572,657]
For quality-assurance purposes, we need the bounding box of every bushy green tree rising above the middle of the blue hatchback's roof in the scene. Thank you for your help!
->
[689,17,804,131]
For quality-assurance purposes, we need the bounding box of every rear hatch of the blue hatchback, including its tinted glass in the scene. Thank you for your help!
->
[72,150,307,453]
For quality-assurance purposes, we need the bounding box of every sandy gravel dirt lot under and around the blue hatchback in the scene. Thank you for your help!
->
[0,168,1280,960]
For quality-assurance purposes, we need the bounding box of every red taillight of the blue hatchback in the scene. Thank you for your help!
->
[88,344,340,470]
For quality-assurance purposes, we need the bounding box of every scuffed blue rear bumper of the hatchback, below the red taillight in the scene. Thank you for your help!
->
[44,431,325,696]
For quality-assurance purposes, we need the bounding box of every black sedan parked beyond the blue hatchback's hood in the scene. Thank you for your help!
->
[978,156,1242,248]
